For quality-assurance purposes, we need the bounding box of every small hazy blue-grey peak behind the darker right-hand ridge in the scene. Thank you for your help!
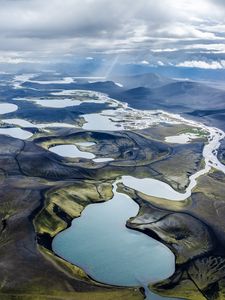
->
[111,73,175,89]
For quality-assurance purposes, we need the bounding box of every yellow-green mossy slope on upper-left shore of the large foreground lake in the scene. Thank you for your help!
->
[34,181,112,237]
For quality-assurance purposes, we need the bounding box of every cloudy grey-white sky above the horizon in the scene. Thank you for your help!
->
[0,0,225,69]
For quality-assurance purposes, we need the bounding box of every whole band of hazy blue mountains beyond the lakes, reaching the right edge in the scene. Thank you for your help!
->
[20,73,225,129]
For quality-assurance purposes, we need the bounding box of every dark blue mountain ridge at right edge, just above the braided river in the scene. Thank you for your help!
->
[110,81,225,130]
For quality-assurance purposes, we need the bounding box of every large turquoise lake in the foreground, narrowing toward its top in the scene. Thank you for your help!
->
[52,183,175,286]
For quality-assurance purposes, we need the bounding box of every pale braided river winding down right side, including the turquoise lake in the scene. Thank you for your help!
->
[49,89,225,299]
